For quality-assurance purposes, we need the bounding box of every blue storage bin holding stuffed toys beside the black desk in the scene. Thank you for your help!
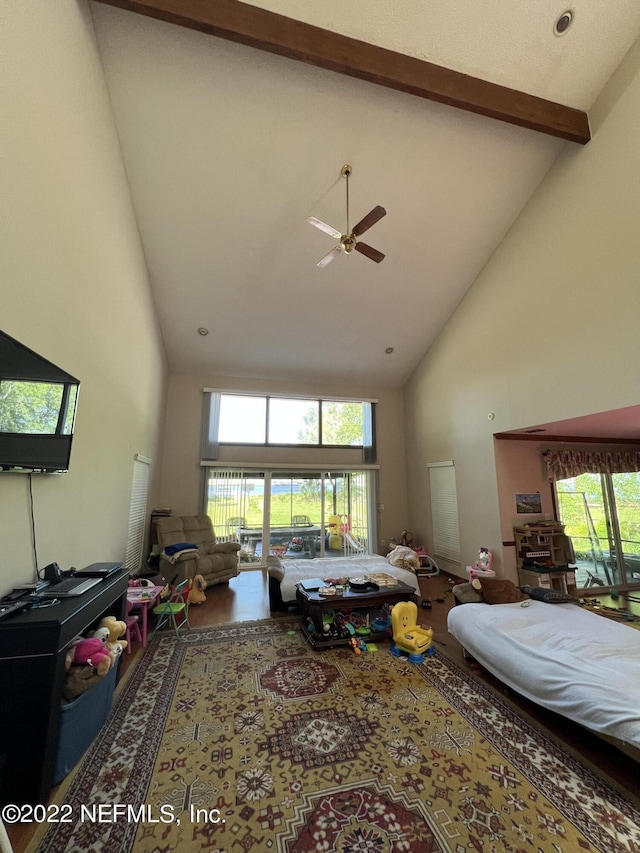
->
[53,665,118,785]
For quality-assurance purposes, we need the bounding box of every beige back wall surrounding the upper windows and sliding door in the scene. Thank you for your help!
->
[159,373,407,550]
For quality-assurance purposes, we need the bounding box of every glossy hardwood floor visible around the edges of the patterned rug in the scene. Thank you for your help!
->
[8,569,640,853]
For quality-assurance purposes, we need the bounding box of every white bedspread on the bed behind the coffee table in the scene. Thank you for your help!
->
[280,554,420,601]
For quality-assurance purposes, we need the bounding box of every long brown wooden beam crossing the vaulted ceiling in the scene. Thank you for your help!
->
[96,0,591,145]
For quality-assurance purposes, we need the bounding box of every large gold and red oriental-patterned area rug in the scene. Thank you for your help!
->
[34,619,640,853]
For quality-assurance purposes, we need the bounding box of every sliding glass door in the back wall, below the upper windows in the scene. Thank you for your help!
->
[204,467,376,568]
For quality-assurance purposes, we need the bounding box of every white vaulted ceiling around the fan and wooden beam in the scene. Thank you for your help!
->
[91,0,640,387]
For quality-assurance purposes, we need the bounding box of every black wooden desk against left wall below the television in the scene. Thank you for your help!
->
[0,569,129,805]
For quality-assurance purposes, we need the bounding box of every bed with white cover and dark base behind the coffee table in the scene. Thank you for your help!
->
[267,554,420,611]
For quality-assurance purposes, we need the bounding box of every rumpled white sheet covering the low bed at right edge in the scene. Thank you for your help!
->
[448,601,640,747]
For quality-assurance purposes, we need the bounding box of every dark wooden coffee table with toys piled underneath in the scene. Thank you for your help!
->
[296,581,416,649]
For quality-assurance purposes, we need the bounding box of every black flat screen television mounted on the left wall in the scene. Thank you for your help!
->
[0,331,80,473]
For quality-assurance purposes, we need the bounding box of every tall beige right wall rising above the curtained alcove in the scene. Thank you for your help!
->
[405,33,640,579]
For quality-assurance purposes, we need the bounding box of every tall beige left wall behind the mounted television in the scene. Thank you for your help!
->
[0,0,166,593]
